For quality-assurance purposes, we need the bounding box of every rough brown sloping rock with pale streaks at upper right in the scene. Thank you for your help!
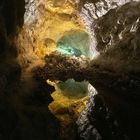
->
[88,2,140,89]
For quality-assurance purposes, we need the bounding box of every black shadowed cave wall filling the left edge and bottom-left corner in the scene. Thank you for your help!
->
[0,0,59,140]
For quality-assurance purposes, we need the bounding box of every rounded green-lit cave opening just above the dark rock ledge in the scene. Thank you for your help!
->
[56,30,91,58]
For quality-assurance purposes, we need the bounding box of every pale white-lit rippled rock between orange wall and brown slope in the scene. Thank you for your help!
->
[79,0,139,57]
